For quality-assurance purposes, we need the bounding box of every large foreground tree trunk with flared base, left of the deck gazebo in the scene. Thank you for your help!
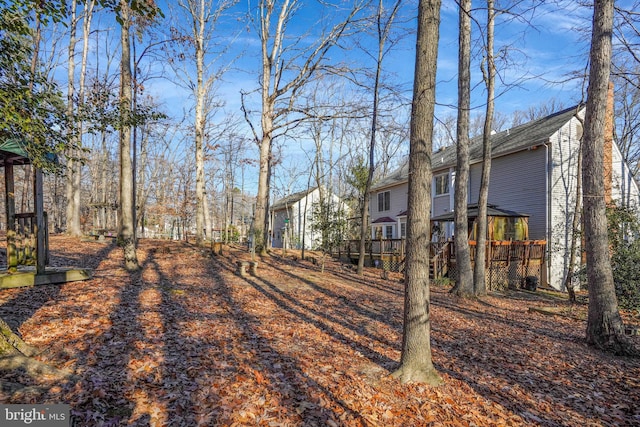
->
[393,0,442,385]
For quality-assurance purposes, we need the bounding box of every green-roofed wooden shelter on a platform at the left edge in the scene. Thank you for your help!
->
[0,139,91,288]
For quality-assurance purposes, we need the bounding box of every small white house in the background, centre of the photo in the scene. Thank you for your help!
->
[270,187,348,249]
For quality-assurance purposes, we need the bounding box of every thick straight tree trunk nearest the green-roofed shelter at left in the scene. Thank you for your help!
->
[118,0,140,271]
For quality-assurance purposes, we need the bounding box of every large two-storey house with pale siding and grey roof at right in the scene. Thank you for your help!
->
[369,107,640,289]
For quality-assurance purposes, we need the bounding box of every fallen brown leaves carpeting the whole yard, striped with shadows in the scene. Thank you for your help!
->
[0,237,640,426]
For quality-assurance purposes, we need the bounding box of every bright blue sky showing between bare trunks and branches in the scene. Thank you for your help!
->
[139,0,591,194]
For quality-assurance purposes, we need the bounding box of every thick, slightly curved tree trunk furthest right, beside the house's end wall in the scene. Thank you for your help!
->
[582,0,634,354]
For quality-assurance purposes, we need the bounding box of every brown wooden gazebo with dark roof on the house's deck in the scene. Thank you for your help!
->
[431,204,529,241]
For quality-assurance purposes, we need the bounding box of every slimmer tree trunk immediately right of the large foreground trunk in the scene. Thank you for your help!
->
[452,0,474,297]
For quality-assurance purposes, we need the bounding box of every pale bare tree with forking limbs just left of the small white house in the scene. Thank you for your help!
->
[242,0,362,253]
